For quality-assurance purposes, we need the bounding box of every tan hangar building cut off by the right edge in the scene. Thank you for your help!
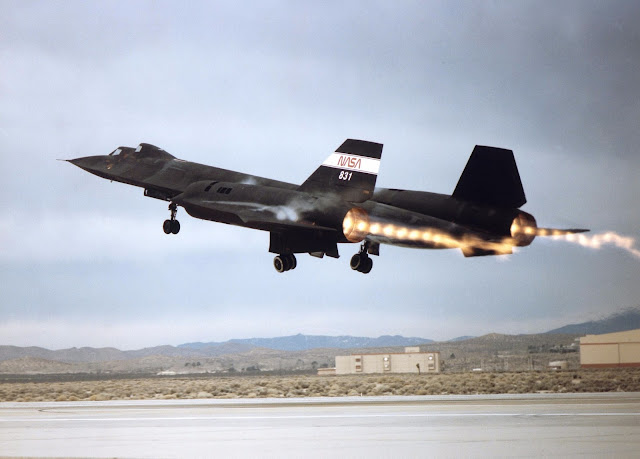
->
[580,329,640,368]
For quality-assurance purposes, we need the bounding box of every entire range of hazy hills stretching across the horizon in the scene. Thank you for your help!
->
[5,306,640,373]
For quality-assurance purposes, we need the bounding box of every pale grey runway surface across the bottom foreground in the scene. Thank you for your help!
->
[0,393,640,458]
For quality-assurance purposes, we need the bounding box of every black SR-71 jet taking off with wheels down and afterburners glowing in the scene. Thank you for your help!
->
[69,139,587,274]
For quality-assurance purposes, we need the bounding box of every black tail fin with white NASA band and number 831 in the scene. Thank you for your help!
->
[298,139,382,202]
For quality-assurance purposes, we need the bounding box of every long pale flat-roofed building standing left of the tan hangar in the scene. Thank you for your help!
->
[335,347,440,375]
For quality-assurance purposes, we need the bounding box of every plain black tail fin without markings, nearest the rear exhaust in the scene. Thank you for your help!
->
[453,145,527,208]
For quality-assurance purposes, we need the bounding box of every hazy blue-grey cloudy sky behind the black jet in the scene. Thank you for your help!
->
[0,0,640,349]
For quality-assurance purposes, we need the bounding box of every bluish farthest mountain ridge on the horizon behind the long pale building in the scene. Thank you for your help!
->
[178,333,433,351]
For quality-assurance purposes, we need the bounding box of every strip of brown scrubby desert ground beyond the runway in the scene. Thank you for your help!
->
[0,368,640,402]
